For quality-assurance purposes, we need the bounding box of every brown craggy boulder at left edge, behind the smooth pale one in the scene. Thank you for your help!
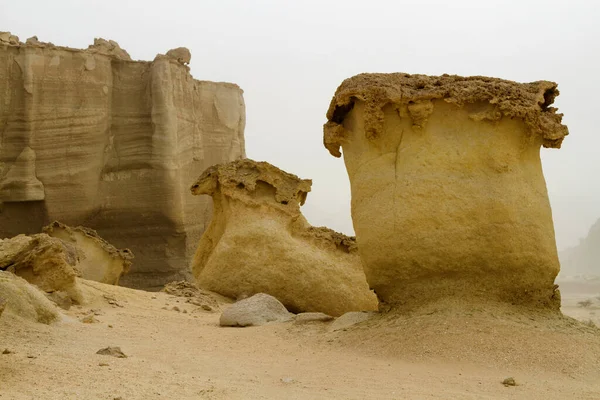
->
[0,233,81,301]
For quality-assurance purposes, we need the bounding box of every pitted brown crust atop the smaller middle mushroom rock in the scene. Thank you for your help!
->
[191,159,312,209]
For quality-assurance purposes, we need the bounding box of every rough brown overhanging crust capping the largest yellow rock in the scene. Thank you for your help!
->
[324,73,568,157]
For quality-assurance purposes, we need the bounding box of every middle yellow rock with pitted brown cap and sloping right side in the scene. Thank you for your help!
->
[192,160,377,315]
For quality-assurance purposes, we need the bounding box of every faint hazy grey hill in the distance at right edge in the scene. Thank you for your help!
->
[559,219,600,278]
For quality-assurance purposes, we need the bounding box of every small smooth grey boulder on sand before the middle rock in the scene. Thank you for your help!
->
[219,293,294,326]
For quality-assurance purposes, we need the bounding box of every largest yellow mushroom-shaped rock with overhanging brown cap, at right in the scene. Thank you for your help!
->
[324,73,568,309]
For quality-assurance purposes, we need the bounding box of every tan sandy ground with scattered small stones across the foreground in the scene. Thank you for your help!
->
[0,282,600,400]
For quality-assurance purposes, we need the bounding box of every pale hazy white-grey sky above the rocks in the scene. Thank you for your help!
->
[0,0,600,249]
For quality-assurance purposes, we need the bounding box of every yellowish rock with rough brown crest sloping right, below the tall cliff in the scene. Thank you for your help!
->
[43,221,133,285]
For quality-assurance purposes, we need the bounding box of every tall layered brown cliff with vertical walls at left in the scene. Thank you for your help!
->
[0,34,245,288]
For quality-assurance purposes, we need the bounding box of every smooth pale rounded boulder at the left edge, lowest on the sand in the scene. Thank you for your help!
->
[0,271,60,324]
